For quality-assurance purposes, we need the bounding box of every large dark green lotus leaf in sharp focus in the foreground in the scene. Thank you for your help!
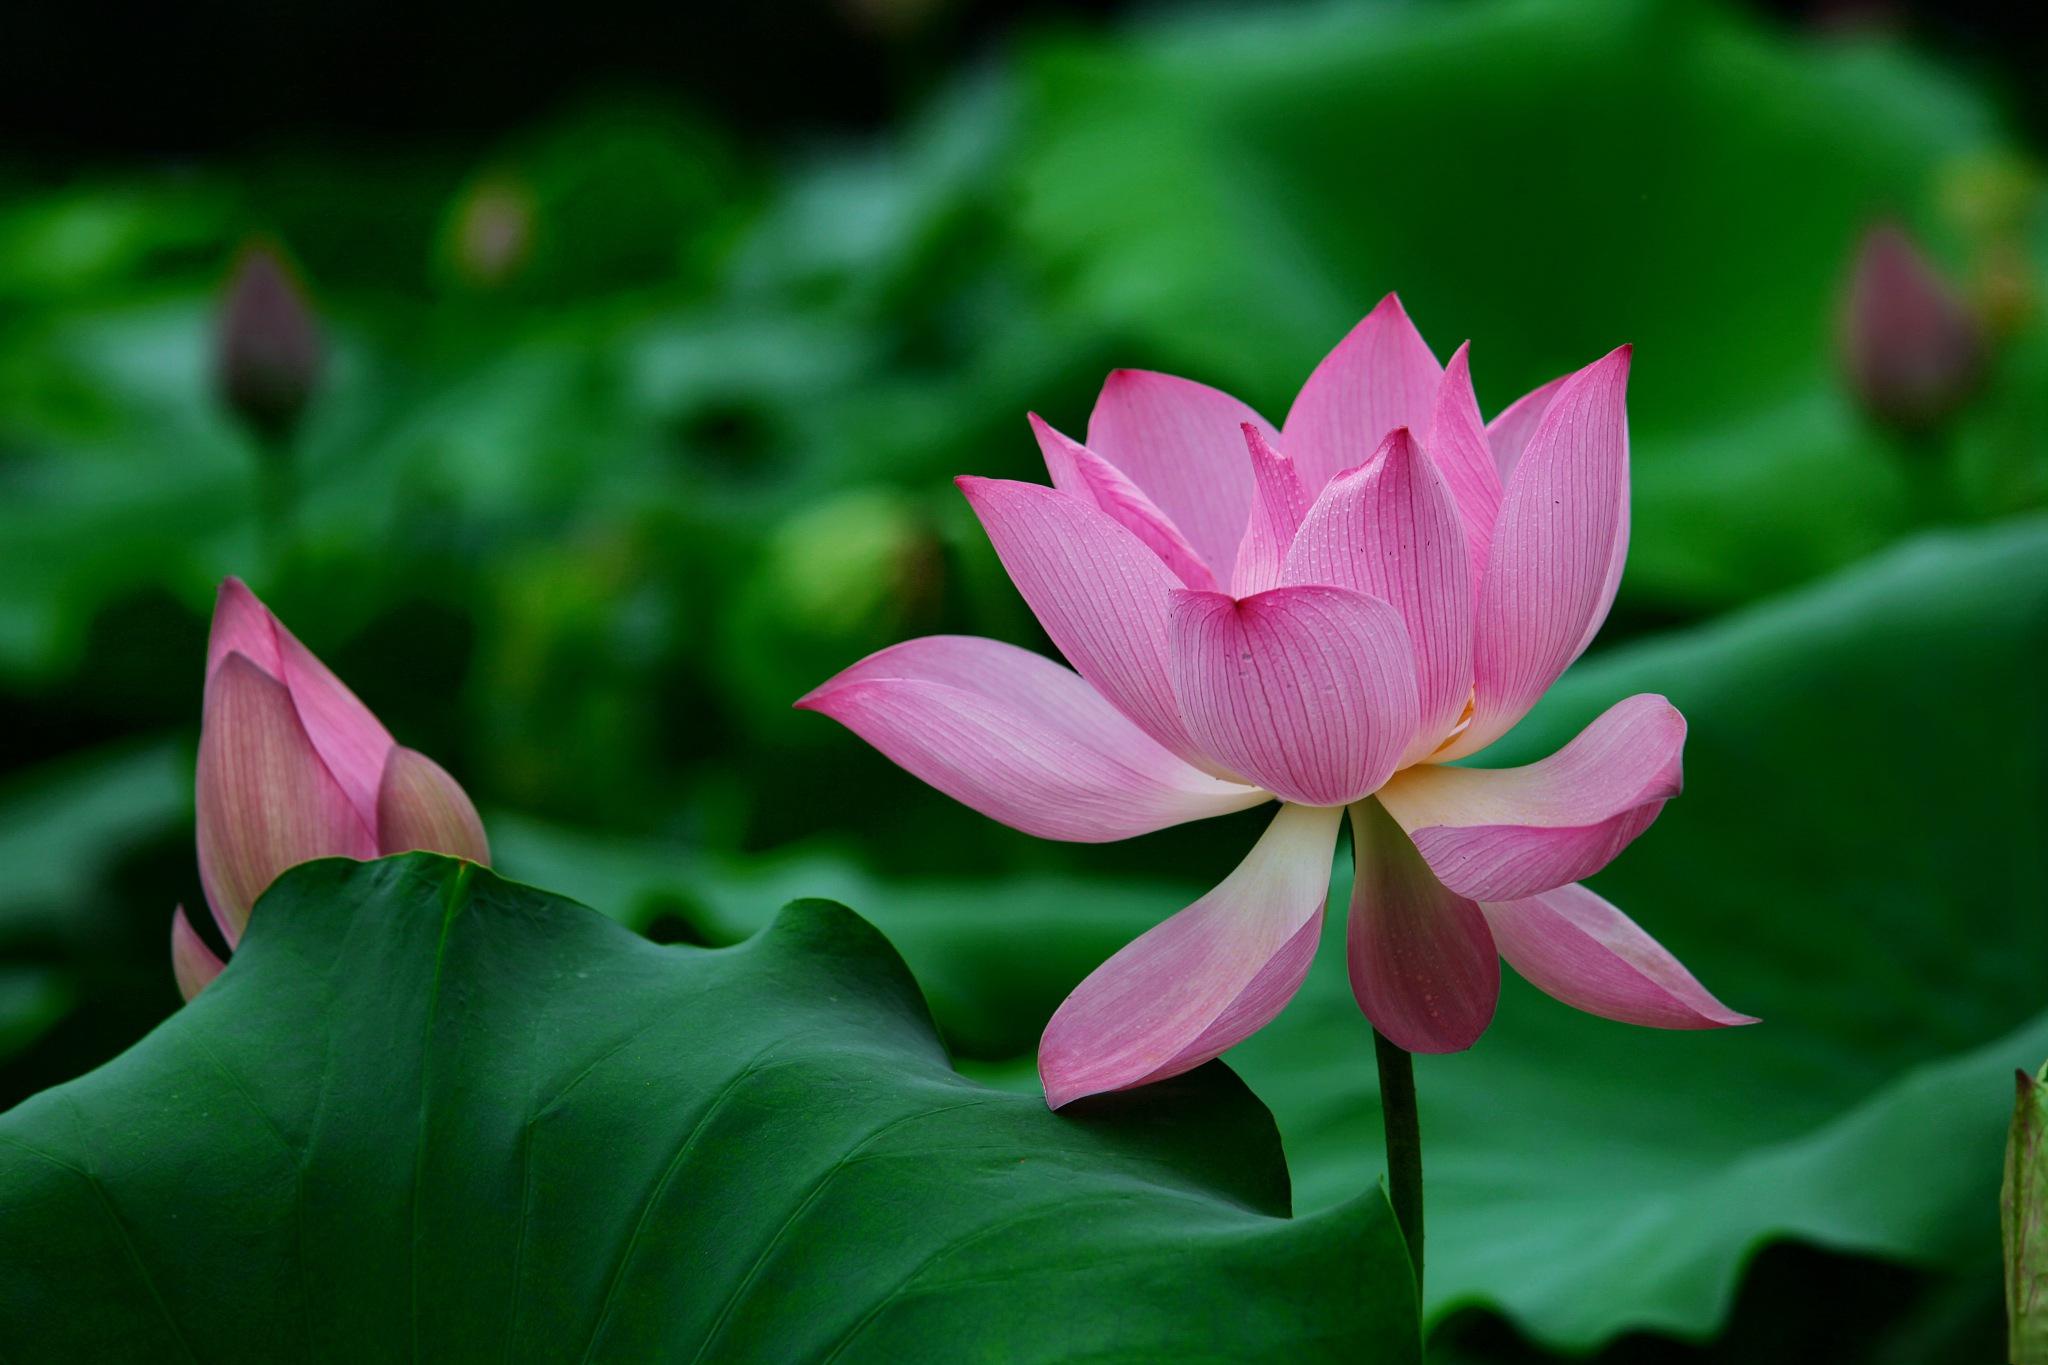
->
[0,855,1415,1361]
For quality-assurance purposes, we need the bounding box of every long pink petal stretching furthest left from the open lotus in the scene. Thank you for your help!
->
[797,634,1268,843]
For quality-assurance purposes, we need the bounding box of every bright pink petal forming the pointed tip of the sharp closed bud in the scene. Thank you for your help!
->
[207,579,393,827]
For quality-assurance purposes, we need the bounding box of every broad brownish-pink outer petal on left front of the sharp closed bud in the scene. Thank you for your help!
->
[199,653,377,945]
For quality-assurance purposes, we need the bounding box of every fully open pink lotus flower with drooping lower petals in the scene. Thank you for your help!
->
[797,295,1753,1109]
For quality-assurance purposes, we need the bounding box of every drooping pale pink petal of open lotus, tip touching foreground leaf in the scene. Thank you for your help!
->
[1038,806,1337,1109]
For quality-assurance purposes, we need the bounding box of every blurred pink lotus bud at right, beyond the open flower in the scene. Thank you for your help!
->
[1841,223,1985,430]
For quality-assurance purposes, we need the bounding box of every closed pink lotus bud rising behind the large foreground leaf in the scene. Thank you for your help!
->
[170,579,492,999]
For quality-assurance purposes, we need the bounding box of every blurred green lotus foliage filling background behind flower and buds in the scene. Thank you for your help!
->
[0,0,2048,1361]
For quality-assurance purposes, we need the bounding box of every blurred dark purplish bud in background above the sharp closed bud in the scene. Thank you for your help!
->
[215,241,326,446]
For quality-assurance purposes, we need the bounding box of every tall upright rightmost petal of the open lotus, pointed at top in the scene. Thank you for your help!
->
[1444,346,1628,759]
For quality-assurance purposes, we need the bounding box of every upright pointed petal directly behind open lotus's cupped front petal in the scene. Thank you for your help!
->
[1282,428,1473,761]
